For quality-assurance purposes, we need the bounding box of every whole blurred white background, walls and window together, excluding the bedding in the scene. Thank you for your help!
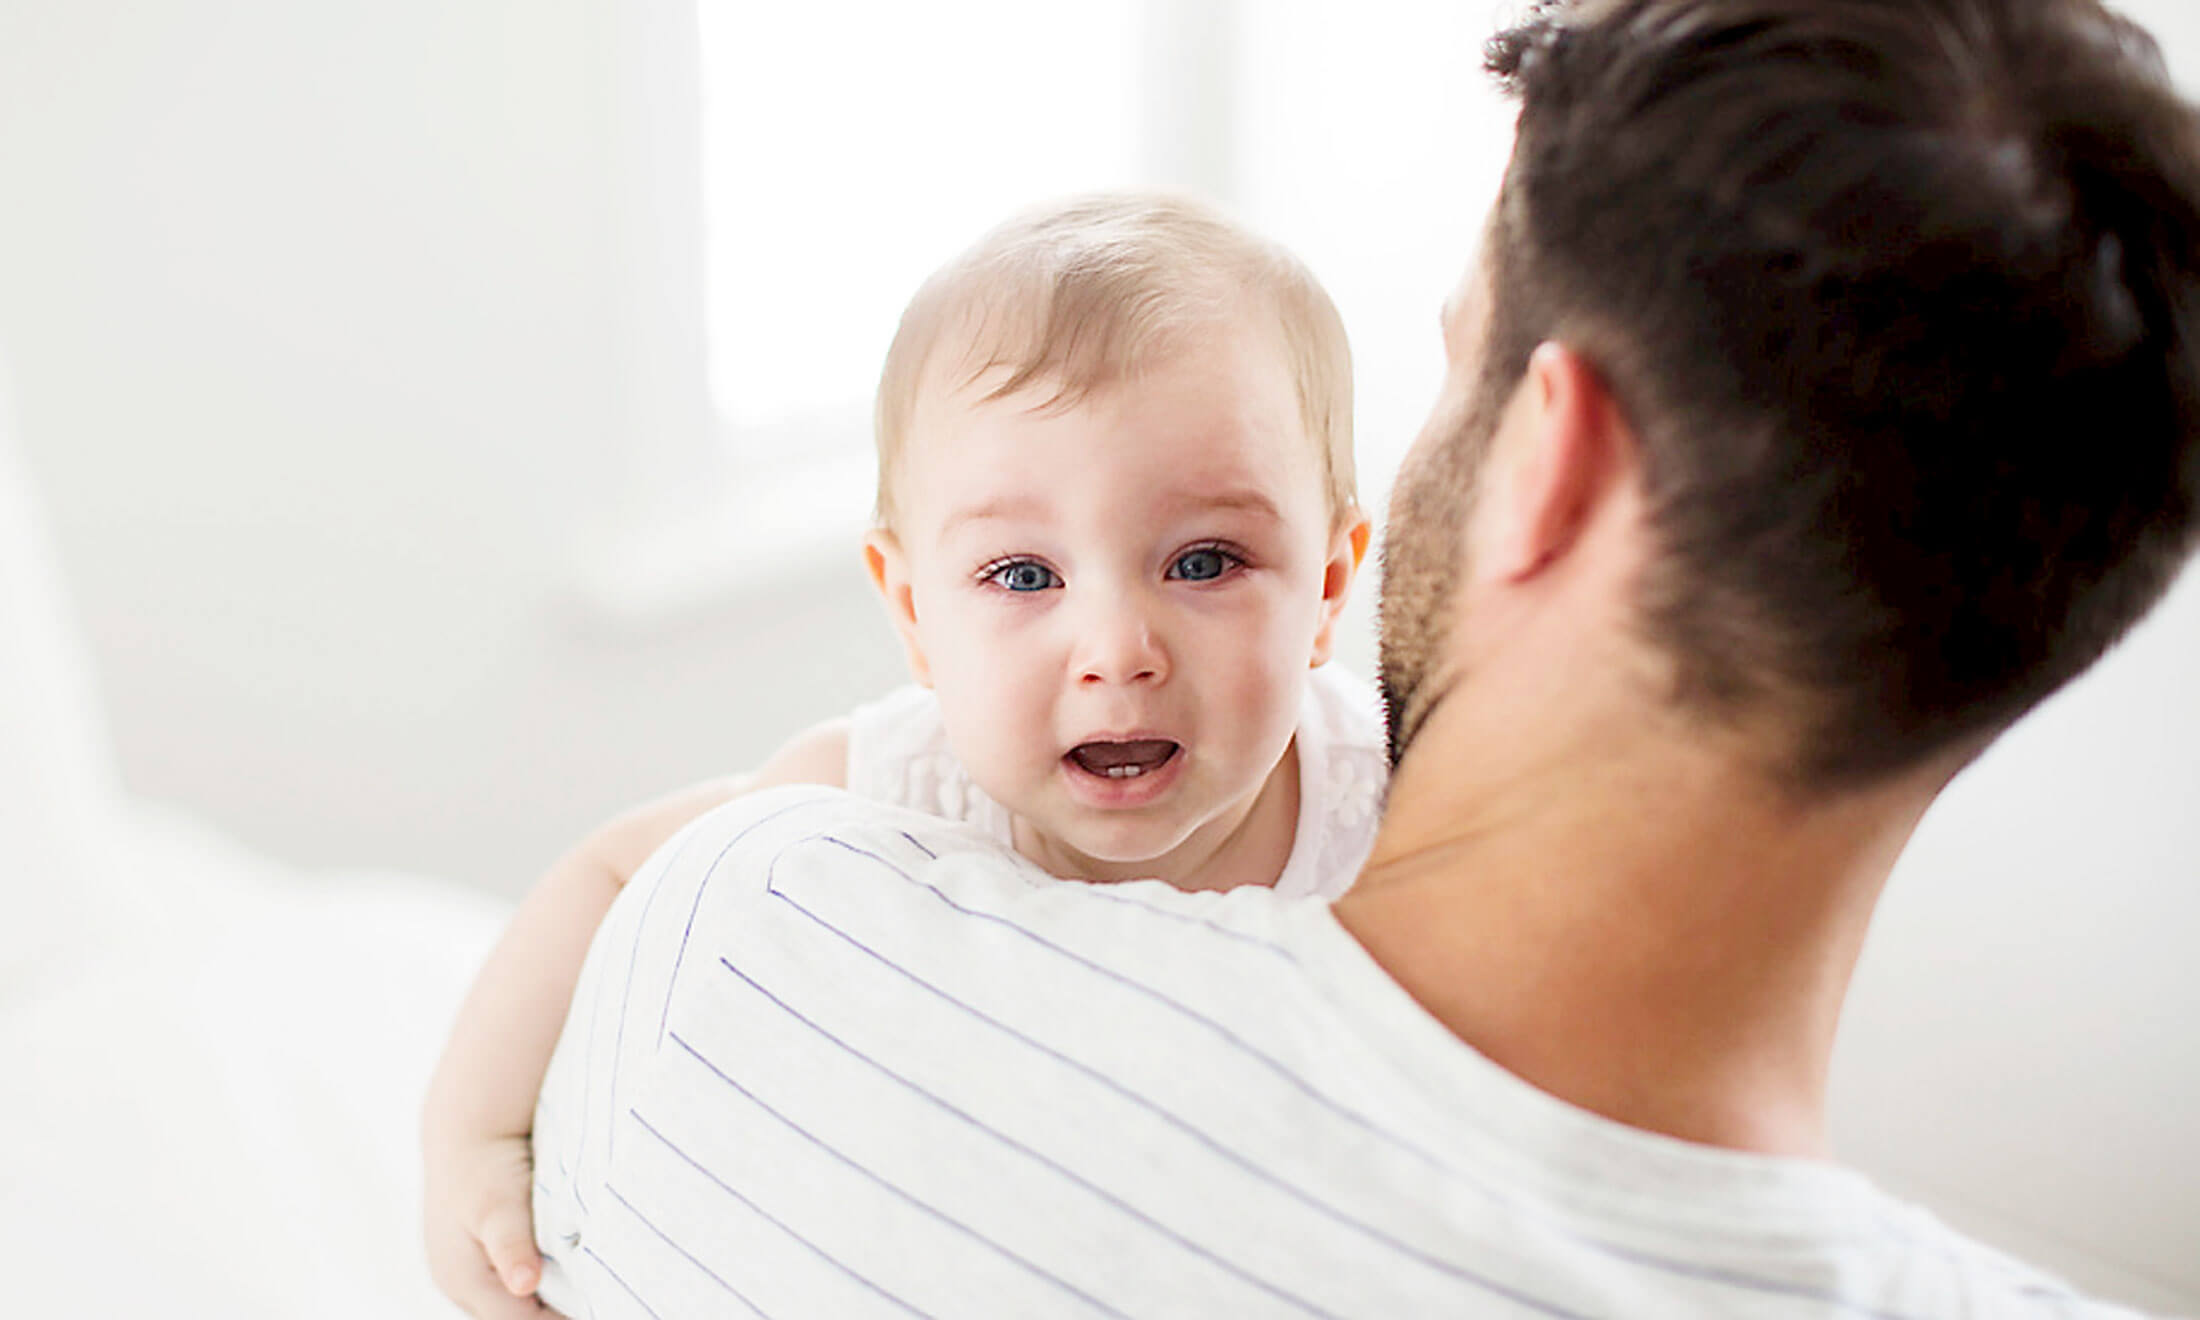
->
[0,0,2200,1309]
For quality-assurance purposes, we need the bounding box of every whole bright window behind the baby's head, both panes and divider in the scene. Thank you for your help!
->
[700,0,1509,491]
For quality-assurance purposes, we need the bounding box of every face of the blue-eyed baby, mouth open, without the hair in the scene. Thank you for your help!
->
[889,319,1357,876]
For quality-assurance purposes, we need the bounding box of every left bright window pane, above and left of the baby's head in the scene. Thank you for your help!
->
[702,0,1142,451]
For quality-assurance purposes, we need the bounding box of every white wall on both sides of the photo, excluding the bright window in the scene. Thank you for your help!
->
[0,0,2200,1307]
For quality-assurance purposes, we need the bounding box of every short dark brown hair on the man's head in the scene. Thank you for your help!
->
[1485,0,2200,790]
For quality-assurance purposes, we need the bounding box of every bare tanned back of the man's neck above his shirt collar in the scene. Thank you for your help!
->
[1335,695,1936,1155]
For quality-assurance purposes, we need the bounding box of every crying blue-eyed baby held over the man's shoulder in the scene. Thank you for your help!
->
[422,196,1384,1316]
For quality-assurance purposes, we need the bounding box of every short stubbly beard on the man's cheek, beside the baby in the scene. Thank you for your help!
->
[1375,383,1505,770]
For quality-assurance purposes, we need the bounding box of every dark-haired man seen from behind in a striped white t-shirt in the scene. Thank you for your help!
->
[535,0,2200,1318]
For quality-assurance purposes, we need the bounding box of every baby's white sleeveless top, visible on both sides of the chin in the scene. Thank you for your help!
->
[847,664,1388,898]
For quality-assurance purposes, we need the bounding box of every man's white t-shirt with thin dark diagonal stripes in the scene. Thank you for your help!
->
[535,788,2112,1320]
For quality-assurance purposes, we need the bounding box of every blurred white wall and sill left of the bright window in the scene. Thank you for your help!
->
[0,0,898,889]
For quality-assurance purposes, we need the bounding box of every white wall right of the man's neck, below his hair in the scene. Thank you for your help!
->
[1833,572,2200,1311]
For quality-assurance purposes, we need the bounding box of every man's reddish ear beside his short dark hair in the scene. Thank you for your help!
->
[1487,343,1635,581]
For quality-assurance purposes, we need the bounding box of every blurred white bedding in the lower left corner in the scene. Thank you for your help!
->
[0,816,499,1320]
